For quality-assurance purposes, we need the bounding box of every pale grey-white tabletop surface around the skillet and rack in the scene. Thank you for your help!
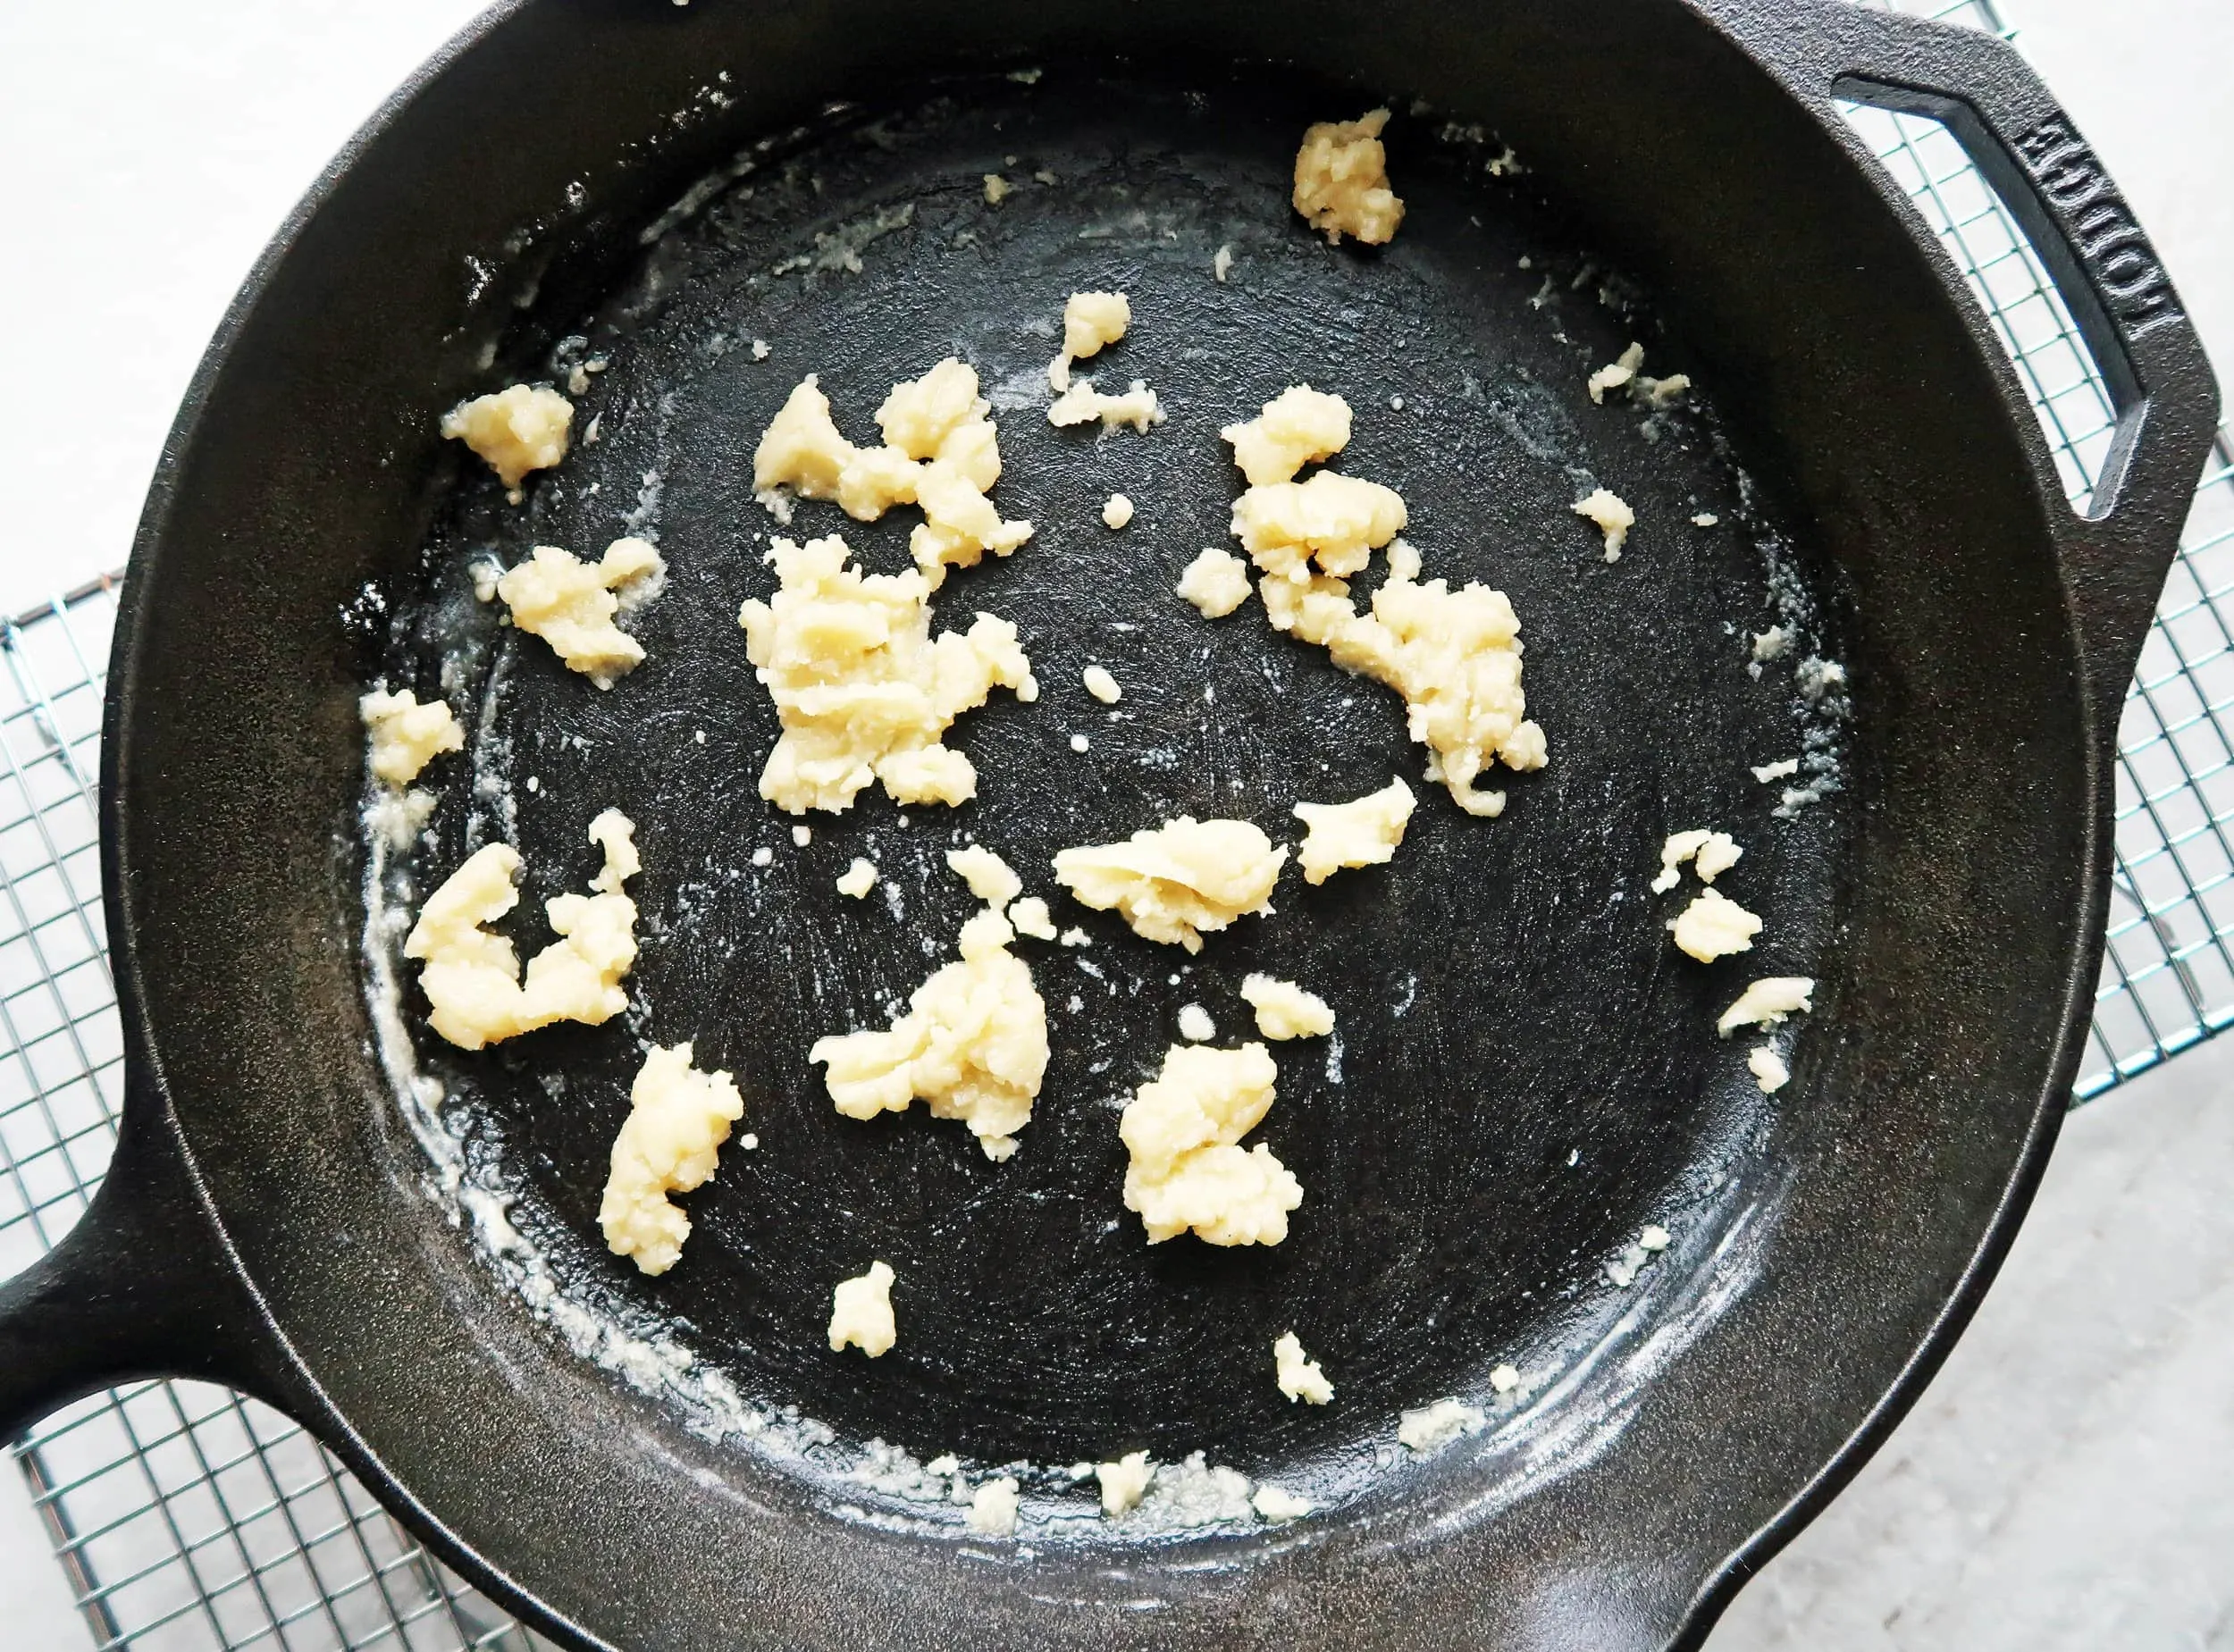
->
[0,0,2234,1652]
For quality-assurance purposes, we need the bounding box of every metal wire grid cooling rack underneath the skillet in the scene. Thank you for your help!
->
[0,0,2234,1652]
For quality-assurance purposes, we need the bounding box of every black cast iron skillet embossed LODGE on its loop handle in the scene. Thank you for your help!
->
[0,0,2216,1650]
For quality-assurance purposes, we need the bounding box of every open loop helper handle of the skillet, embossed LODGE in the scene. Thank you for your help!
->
[1709,0,2219,742]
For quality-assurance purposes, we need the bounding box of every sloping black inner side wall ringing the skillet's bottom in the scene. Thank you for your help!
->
[110,0,2095,1648]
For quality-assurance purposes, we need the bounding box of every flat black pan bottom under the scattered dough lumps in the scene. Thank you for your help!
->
[369,71,1859,1507]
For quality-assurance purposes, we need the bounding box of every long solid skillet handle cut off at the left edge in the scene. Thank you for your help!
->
[0,1076,277,1440]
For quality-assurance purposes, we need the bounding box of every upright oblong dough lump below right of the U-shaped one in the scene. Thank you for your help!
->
[597,1044,744,1272]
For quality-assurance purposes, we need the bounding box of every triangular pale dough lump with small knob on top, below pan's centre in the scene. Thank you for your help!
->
[807,909,1048,1159]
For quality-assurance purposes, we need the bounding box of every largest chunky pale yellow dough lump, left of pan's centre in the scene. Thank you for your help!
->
[737,533,1039,815]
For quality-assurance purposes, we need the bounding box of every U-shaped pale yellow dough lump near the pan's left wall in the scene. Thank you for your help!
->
[405,809,639,1049]
